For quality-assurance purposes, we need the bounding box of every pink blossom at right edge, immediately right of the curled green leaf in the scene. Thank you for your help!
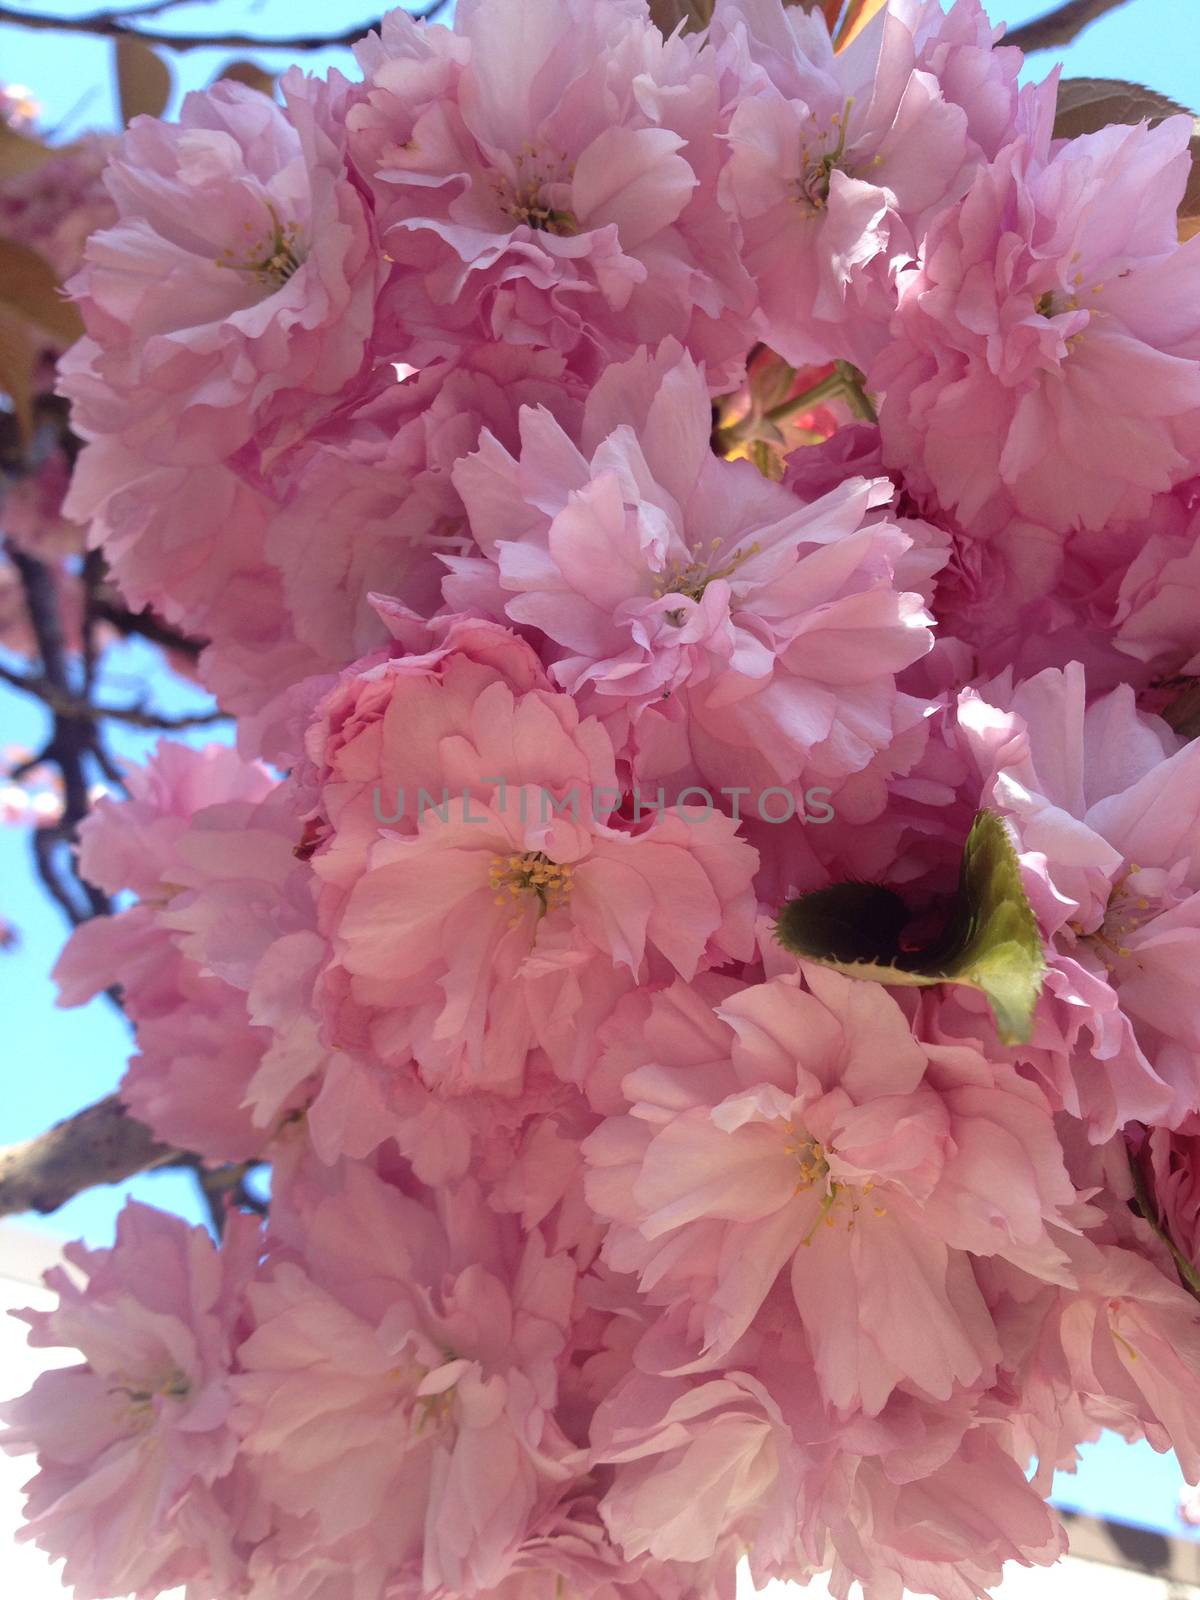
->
[958,666,1200,1139]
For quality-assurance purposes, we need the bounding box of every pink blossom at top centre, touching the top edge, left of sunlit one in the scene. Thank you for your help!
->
[347,0,754,387]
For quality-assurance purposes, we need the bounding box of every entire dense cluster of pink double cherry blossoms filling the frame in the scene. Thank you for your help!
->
[6,0,1200,1600]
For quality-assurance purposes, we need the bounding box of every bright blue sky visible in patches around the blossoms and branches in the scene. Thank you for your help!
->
[0,0,1200,1533]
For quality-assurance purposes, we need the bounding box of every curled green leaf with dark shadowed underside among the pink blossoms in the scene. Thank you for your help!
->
[776,811,1045,1045]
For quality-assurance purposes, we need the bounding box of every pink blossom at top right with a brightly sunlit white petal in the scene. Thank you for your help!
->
[710,0,1021,366]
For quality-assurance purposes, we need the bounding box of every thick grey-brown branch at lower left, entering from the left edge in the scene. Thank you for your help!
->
[0,1094,176,1216]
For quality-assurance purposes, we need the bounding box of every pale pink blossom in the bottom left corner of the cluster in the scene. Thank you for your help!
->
[3,1202,258,1600]
